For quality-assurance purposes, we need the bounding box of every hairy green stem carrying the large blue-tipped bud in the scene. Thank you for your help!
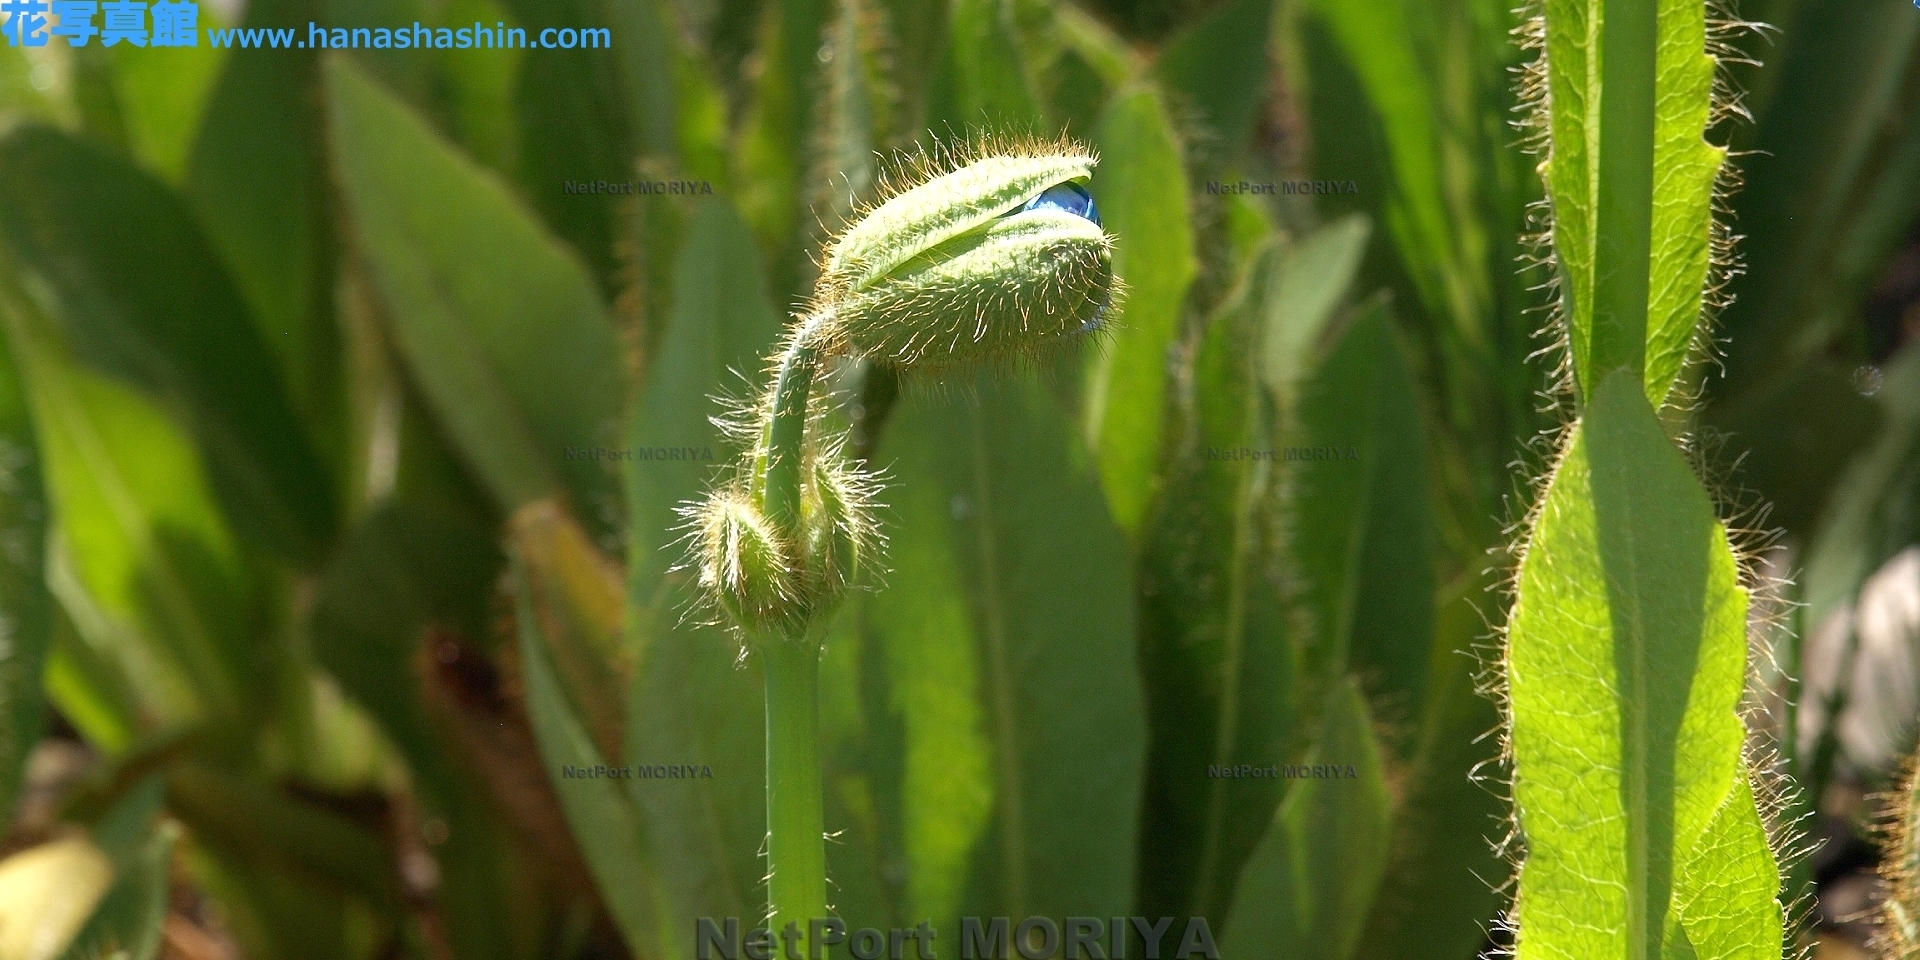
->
[751,315,828,956]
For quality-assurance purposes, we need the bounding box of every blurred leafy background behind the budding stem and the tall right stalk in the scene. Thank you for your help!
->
[0,0,1920,960]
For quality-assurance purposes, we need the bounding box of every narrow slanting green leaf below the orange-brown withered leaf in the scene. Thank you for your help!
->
[511,557,666,954]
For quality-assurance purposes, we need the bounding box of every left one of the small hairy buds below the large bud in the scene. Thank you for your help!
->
[697,490,806,634]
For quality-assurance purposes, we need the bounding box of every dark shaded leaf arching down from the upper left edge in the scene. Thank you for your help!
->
[0,127,336,566]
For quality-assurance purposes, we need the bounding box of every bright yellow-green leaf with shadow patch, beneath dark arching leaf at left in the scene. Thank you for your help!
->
[0,275,263,735]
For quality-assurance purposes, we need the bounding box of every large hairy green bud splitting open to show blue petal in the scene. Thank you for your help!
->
[816,146,1116,367]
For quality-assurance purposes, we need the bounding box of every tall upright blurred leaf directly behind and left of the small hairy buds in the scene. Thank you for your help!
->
[624,200,781,952]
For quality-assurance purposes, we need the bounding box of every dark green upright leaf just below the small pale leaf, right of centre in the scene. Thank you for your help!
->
[1283,301,1434,720]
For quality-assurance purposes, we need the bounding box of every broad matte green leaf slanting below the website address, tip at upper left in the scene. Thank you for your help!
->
[326,60,620,518]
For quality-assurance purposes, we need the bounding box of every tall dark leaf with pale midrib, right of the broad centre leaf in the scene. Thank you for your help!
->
[1139,248,1304,916]
